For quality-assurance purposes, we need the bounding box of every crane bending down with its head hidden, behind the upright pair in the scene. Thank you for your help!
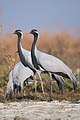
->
[6,62,34,96]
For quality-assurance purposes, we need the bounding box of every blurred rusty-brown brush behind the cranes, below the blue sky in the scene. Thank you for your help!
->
[0,29,80,101]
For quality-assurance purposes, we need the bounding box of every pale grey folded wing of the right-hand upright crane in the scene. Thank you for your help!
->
[37,51,71,74]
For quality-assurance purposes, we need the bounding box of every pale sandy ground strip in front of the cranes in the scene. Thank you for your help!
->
[0,101,80,120]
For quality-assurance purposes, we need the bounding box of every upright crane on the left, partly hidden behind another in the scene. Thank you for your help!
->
[14,30,64,94]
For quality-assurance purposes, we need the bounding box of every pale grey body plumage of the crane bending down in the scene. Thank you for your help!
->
[13,62,34,88]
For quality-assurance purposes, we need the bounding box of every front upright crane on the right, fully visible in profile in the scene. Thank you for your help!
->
[30,29,77,96]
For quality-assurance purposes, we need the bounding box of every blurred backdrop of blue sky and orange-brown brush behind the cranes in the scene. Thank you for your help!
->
[0,0,80,101]
